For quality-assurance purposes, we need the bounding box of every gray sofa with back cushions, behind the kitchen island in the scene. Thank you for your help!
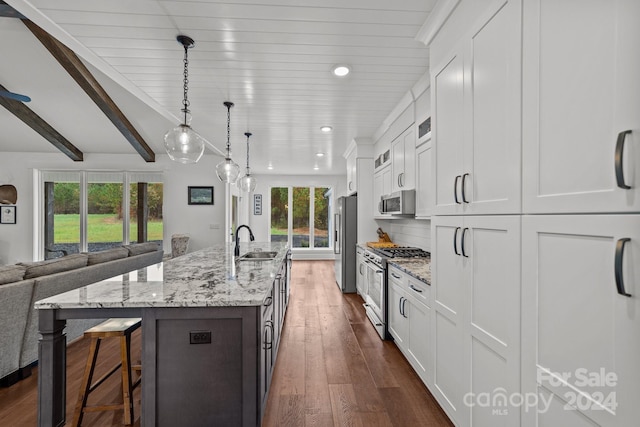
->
[0,242,163,386]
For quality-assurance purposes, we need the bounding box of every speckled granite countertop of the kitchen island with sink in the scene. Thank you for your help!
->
[35,242,288,309]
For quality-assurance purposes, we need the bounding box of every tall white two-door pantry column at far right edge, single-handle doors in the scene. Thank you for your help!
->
[522,0,640,427]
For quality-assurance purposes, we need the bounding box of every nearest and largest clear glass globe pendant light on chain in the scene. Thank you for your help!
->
[164,35,205,163]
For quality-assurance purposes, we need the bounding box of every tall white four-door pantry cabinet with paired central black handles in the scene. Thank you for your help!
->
[431,1,522,427]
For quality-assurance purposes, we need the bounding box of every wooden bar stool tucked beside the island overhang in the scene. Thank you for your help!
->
[72,318,142,427]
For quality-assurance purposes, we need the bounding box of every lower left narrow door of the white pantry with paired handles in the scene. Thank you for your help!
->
[431,216,468,423]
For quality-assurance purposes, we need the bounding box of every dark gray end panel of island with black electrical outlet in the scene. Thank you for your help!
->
[142,307,260,427]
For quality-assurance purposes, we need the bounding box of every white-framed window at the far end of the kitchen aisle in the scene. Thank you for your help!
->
[271,187,330,248]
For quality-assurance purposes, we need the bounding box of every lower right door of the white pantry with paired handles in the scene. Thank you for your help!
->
[461,216,521,427]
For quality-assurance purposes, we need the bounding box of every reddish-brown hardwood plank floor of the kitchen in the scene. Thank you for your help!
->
[0,261,453,427]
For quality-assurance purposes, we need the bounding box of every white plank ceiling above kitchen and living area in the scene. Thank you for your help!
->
[0,0,436,174]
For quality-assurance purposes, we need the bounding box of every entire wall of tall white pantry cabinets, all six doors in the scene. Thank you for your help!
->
[430,0,640,427]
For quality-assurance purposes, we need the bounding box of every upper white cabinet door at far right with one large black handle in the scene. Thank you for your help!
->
[523,0,640,213]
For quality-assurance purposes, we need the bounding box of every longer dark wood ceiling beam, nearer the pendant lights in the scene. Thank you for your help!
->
[22,19,156,162]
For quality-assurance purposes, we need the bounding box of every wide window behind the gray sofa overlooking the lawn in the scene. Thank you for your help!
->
[37,171,163,259]
